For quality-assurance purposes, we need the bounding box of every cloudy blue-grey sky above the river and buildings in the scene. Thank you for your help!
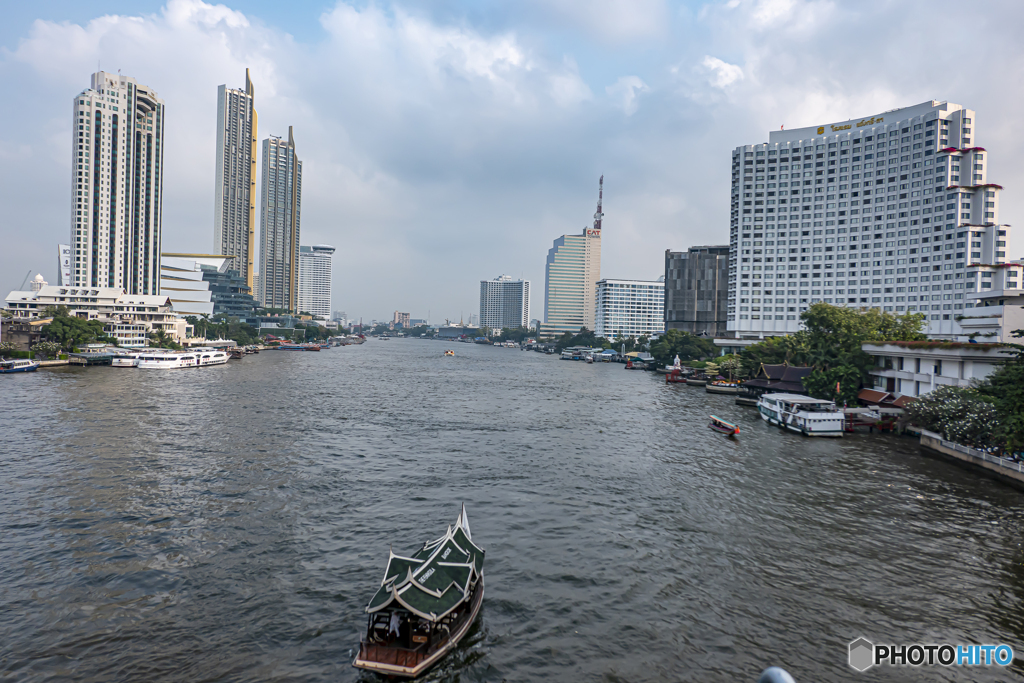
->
[0,0,1024,323]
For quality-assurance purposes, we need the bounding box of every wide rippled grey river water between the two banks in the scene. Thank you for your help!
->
[0,339,1024,683]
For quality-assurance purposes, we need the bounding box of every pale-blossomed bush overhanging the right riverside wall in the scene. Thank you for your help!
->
[904,384,999,449]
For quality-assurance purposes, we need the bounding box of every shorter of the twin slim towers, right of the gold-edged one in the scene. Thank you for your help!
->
[259,126,302,310]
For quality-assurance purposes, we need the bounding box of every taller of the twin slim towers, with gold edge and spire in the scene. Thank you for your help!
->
[213,69,256,294]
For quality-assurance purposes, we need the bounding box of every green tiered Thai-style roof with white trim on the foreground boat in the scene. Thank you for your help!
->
[367,506,484,622]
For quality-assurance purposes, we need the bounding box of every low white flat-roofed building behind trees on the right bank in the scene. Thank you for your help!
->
[861,341,1012,397]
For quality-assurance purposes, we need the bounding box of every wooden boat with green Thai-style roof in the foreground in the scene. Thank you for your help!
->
[352,506,484,678]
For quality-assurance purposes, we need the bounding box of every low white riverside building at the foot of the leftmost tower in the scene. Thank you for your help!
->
[5,285,191,343]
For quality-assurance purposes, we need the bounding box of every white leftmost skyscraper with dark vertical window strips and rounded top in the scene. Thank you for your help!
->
[66,71,164,294]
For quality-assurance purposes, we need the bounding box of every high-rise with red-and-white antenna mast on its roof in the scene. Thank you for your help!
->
[540,175,604,337]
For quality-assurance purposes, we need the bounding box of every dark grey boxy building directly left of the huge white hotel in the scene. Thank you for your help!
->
[665,245,729,337]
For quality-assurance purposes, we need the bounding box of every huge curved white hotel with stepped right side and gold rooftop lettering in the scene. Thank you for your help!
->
[728,101,1008,338]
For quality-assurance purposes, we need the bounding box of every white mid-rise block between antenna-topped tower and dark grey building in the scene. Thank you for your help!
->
[594,278,665,341]
